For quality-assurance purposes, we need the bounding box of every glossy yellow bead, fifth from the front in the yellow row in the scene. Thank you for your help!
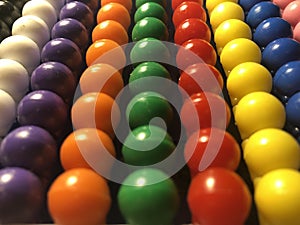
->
[220,38,261,75]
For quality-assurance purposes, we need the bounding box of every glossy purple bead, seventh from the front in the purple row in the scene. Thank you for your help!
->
[59,1,94,30]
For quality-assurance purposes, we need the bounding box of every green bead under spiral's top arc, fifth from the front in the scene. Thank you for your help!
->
[130,38,170,65]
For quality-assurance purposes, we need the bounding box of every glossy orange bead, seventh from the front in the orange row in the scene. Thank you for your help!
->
[97,2,131,30]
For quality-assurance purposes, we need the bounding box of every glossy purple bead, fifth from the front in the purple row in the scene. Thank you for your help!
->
[41,38,83,76]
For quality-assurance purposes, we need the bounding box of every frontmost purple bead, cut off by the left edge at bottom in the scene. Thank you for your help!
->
[0,167,45,224]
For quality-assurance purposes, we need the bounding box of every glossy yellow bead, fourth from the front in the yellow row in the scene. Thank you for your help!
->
[226,62,272,106]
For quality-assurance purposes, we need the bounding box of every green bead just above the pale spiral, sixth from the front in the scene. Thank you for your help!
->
[131,17,169,41]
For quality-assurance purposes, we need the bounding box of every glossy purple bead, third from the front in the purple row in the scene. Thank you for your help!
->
[17,90,68,137]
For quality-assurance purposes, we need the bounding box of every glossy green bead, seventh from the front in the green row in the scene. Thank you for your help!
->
[134,2,168,24]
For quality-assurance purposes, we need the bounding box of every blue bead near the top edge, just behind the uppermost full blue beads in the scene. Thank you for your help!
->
[246,1,280,29]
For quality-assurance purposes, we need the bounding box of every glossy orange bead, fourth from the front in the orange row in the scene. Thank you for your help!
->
[79,63,124,98]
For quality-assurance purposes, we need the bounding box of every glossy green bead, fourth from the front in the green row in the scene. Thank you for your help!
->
[129,62,171,95]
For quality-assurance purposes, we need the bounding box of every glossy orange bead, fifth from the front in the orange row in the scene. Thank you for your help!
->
[85,39,126,69]
